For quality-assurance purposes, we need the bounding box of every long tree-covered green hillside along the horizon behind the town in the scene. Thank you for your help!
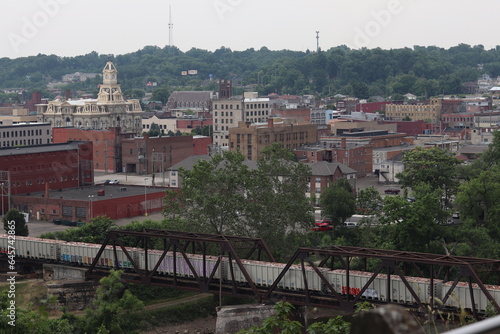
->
[0,44,500,102]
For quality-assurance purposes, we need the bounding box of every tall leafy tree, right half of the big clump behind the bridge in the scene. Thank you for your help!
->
[243,144,314,259]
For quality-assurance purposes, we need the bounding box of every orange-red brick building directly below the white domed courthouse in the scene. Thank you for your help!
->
[52,127,134,173]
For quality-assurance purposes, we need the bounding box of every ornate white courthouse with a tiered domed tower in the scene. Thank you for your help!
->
[37,61,143,134]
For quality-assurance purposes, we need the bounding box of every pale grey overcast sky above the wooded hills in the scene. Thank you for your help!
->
[0,0,500,58]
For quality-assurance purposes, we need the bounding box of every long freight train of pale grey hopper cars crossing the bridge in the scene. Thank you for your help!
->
[0,235,500,313]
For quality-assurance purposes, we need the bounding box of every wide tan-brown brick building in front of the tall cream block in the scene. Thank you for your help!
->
[229,118,318,161]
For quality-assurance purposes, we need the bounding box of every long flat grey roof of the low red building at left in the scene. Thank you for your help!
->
[16,184,166,202]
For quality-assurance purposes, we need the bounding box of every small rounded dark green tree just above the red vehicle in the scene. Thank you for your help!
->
[320,178,356,230]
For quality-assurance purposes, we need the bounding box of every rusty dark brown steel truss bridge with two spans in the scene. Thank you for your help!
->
[80,229,500,318]
